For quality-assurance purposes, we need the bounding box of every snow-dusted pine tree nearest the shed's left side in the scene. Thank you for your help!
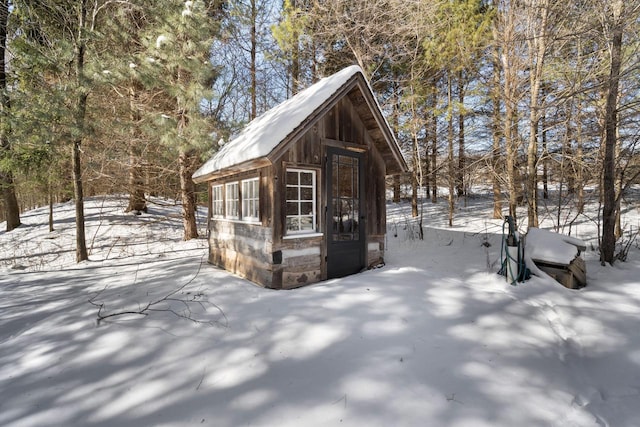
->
[135,0,218,240]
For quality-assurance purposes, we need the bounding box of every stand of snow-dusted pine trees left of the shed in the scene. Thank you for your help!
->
[0,0,222,261]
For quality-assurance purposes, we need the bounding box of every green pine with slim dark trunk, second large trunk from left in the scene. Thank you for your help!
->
[12,0,140,262]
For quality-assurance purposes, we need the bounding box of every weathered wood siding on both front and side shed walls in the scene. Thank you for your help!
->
[209,82,396,289]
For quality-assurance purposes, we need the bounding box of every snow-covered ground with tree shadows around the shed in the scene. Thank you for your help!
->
[0,197,640,427]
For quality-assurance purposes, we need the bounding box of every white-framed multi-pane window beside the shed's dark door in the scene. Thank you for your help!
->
[286,169,317,234]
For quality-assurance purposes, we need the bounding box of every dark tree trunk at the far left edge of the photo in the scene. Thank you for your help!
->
[0,0,20,231]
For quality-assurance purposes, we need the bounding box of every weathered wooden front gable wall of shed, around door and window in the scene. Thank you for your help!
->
[273,88,386,288]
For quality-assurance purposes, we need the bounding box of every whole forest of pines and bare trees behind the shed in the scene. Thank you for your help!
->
[0,0,640,263]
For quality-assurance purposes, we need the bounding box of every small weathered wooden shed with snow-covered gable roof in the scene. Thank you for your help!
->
[193,66,407,289]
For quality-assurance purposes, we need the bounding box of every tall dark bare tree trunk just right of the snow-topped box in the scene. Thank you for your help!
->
[600,0,624,264]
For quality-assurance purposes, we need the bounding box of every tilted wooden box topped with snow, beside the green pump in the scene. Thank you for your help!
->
[524,227,587,289]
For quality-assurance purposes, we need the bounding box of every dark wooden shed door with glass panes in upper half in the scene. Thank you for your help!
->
[326,147,366,279]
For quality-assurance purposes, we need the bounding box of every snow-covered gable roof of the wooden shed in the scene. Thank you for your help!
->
[192,65,406,182]
